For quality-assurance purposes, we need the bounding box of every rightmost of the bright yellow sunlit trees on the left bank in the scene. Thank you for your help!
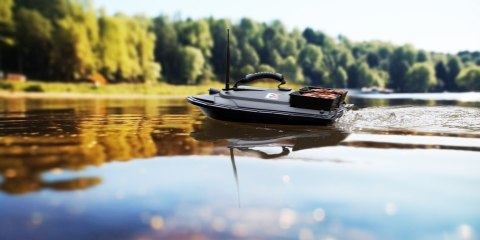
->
[99,13,161,82]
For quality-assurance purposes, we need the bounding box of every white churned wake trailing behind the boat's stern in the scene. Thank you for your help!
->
[336,106,480,137]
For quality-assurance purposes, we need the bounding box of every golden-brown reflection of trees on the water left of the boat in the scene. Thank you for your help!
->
[0,99,213,194]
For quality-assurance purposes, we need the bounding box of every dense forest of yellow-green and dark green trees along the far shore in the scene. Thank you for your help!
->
[0,0,480,92]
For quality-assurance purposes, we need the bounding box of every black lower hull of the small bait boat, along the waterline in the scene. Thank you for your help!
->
[187,97,348,125]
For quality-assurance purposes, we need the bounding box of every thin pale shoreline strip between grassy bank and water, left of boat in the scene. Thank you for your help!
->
[0,92,188,99]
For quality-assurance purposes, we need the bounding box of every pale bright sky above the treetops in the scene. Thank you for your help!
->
[94,0,480,53]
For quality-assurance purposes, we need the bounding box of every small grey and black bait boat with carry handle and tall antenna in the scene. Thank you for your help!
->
[187,29,353,125]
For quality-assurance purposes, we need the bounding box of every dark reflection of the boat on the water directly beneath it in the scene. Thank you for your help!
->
[190,118,348,159]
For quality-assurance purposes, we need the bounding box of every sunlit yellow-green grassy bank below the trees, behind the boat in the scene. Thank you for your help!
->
[0,81,299,96]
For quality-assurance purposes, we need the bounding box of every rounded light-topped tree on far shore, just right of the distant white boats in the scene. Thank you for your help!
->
[405,63,437,92]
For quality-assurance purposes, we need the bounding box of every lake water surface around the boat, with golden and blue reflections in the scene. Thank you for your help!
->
[0,92,480,240]
